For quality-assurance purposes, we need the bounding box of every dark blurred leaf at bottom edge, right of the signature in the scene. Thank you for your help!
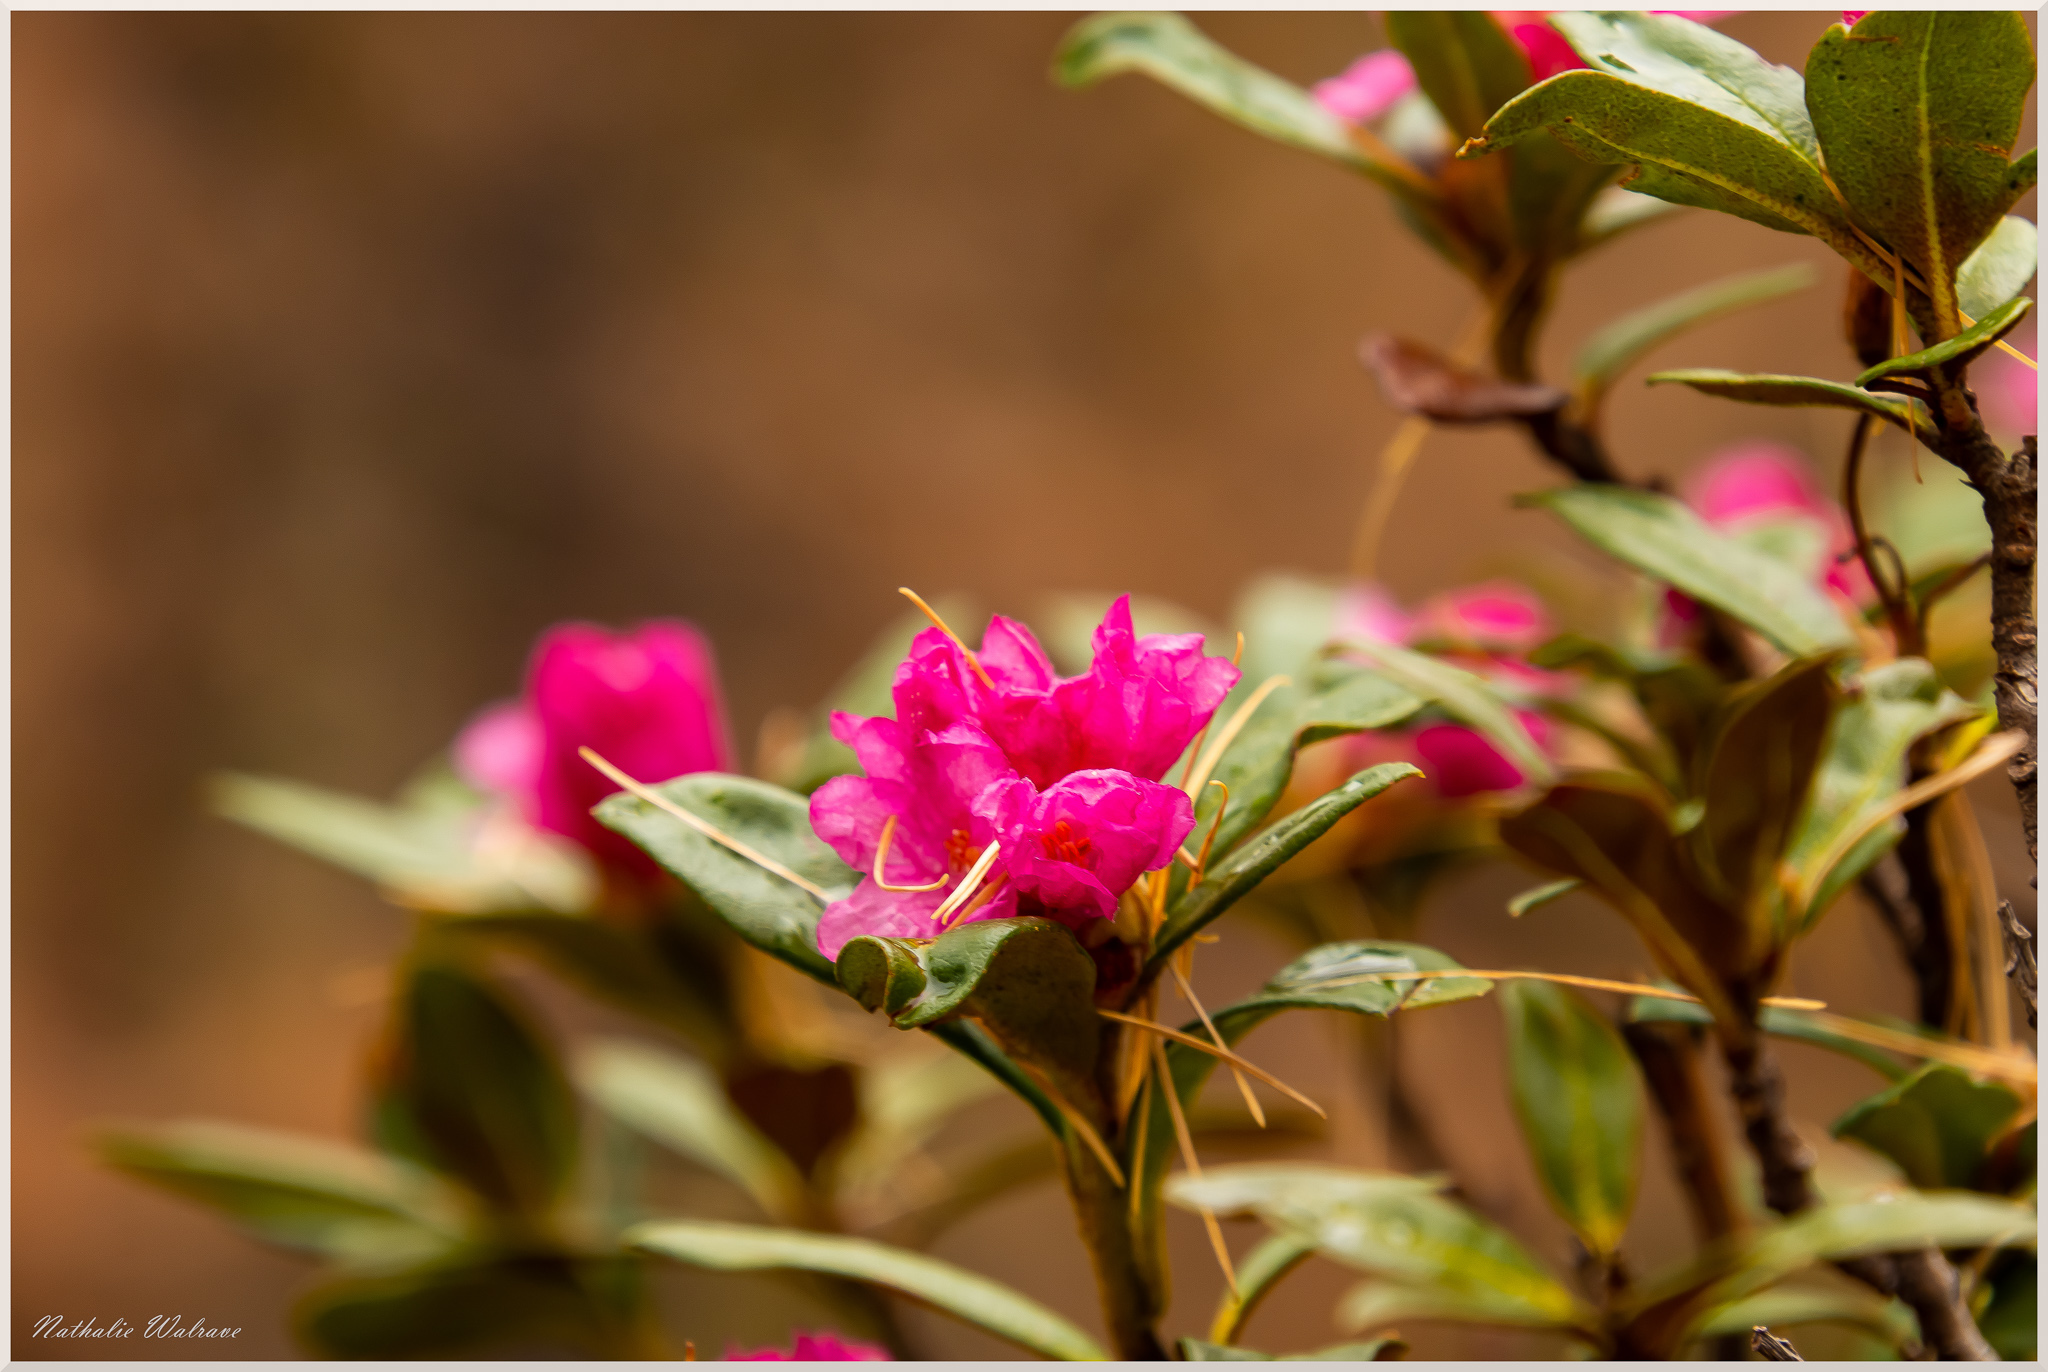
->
[293,1255,659,1362]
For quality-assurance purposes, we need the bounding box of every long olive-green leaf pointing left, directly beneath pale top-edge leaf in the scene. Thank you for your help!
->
[1460,72,1876,270]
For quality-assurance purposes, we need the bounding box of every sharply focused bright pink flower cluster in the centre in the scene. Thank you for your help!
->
[811,596,1237,958]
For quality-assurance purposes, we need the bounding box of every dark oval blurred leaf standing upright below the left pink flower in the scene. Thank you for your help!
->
[385,964,578,1216]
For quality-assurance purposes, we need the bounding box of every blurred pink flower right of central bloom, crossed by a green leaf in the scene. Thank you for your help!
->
[1337,582,1556,801]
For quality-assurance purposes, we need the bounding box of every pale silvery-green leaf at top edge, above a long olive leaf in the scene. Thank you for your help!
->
[1550,10,1821,164]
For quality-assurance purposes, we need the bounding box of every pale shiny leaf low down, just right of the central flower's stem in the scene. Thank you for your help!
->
[1167,1163,1597,1329]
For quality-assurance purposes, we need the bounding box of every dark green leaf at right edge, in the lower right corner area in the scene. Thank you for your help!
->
[1831,1063,2021,1190]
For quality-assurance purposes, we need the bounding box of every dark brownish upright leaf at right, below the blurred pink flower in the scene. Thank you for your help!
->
[1686,655,1841,925]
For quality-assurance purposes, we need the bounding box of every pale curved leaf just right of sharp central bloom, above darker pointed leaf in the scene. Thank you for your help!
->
[1176,663,1427,872]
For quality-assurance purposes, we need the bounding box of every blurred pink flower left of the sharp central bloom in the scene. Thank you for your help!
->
[455,620,733,874]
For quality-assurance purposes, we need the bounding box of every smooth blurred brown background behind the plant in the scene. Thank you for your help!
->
[12,14,2032,1358]
